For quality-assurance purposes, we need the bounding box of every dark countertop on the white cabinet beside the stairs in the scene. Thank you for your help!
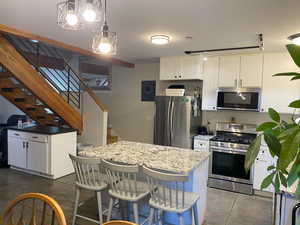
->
[7,126,76,135]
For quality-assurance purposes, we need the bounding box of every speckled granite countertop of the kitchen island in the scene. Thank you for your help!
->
[78,141,210,173]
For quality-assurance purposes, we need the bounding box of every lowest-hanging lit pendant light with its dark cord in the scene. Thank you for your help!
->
[92,0,117,55]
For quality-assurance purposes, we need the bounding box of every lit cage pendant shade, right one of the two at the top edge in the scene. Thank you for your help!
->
[80,0,102,23]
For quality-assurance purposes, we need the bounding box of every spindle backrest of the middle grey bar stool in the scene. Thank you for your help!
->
[102,160,139,197]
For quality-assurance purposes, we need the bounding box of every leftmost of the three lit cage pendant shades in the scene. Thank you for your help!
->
[57,0,83,30]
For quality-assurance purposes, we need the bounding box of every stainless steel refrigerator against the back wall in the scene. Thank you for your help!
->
[154,96,202,149]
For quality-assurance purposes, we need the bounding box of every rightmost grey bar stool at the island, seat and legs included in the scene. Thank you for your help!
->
[143,166,200,225]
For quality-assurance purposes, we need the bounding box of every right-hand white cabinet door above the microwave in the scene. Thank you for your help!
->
[238,54,263,87]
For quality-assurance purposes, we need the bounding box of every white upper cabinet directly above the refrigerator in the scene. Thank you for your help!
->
[160,55,203,80]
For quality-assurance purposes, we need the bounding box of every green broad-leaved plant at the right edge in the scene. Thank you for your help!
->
[245,44,300,196]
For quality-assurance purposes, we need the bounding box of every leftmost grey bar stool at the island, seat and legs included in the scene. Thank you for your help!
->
[69,154,108,225]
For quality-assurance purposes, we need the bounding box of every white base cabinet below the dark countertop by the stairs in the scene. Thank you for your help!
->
[8,130,77,179]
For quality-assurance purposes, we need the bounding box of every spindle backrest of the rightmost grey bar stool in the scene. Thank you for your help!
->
[143,166,188,209]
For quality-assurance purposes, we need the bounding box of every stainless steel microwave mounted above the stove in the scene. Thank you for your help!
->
[217,88,261,111]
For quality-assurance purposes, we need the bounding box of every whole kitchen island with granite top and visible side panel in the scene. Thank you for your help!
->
[79,141,210,224]
